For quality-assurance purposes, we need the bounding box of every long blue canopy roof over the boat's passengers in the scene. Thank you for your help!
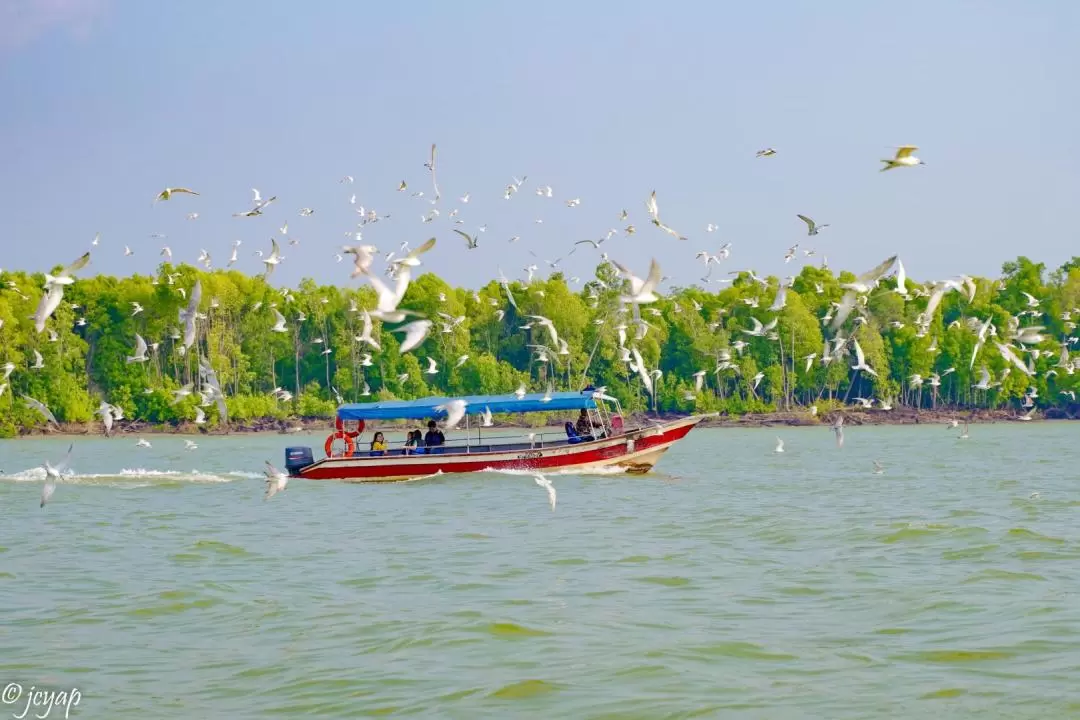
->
[338,391,596,420]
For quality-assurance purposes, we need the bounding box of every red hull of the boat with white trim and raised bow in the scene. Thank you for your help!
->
[294,416,702,483]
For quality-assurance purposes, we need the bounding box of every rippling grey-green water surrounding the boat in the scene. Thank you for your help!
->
[0,424,1080,719]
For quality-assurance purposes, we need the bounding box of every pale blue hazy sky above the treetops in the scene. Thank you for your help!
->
[0,0,1080,288]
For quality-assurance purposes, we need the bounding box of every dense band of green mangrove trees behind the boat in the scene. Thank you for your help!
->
[0,257,1080,436]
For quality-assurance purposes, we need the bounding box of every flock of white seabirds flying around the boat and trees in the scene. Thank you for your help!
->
[14,145,1062,508]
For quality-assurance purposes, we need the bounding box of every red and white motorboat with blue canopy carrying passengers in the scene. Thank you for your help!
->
[285,389,704,483]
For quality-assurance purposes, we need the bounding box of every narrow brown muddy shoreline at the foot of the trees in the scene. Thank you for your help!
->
[10,408,1078,439]
